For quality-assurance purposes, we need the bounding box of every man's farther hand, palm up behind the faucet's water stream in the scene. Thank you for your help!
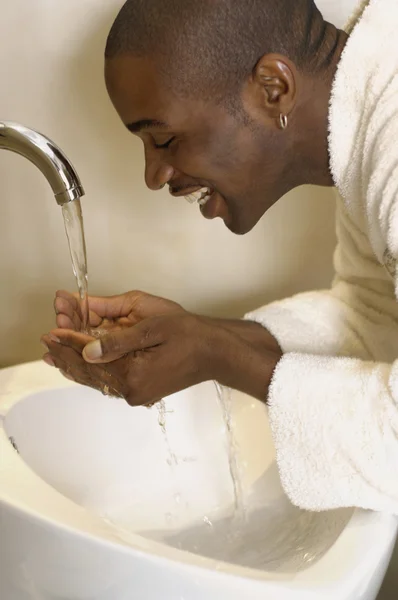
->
[54,291,185,337]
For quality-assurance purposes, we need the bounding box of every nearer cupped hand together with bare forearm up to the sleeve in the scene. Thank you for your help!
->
[43,294,282,405]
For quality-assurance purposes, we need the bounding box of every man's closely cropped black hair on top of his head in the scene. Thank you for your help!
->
[105,0,325,98]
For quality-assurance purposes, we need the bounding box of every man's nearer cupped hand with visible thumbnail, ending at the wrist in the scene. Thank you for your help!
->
[42,310,228,406]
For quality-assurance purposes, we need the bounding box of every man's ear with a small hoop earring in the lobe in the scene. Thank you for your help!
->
[245,54,297,127]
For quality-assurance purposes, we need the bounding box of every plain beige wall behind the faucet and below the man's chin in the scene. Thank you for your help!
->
[0,0,342,366]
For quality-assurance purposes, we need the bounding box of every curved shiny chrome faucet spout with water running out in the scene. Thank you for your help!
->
[0,121,84,206]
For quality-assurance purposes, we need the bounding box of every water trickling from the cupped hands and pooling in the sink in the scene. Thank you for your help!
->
[103,383,352,574]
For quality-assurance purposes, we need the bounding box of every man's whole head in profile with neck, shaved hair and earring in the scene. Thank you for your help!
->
[105,0,341,233]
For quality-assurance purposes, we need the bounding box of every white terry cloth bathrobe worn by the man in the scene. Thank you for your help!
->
[246,0,398,514]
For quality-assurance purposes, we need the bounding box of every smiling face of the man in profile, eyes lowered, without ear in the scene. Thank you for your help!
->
[105,55,291,234]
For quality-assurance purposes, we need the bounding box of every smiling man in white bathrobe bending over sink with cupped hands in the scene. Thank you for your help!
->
[44,0,398,513]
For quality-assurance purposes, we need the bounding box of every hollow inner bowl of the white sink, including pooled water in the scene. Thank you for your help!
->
[4,382,353,579]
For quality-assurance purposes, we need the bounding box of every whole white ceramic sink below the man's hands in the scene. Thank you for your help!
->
[0,363,397,600]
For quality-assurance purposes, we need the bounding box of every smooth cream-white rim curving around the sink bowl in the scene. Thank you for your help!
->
[0,361,398,594]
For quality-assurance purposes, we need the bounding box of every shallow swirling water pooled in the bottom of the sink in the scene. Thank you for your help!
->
[141,488,352,573]
